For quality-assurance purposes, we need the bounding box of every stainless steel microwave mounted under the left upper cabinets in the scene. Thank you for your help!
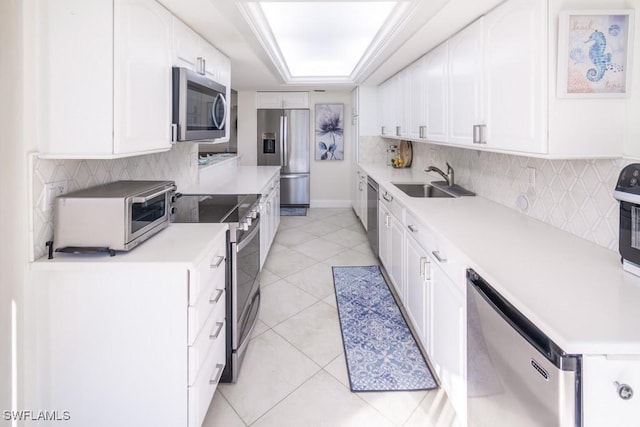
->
[173,67,227,141]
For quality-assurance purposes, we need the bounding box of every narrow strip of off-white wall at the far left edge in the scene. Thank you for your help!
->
[0,0,27,410]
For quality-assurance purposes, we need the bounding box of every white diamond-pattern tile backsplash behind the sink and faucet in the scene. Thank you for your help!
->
[360,137,630,251]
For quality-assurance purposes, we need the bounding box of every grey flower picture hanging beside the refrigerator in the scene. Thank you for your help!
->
[315,104,344,161]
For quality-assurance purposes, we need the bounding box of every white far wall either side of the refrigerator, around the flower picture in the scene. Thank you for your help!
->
[238,91,352,207]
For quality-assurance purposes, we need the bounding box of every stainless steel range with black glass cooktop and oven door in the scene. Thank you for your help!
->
[173,194,260,382]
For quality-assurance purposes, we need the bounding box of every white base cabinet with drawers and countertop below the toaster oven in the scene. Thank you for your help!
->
[33,224,226,427]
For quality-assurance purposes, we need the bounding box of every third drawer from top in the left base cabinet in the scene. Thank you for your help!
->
[189,295,226,385]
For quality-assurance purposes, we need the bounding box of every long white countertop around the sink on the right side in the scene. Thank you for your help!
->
[360,164,640,355]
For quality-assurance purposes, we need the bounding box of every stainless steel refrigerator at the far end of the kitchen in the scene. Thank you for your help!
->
[257,110,311,207]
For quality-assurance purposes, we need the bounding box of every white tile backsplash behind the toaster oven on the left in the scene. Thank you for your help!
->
[31,143,198,259]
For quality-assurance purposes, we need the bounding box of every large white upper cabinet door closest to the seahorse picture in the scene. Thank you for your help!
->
[478,0,548,153]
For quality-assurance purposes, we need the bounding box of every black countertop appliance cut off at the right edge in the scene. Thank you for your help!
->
[613,163,640,276]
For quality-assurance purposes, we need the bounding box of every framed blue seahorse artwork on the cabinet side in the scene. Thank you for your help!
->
[557,9,634,98]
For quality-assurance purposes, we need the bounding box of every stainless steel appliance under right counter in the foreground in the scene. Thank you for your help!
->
[467,269,582,427]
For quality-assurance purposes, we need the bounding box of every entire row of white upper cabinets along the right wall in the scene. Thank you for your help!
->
[379,0,629,158]
